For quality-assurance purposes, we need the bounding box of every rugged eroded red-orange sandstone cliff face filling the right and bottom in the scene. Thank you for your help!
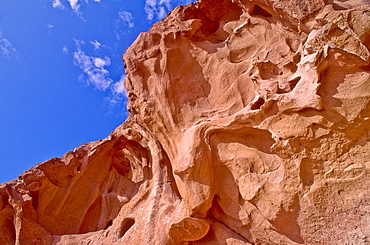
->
[0,0,370,245]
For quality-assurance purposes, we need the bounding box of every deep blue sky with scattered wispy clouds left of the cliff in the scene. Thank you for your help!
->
[0,0,194,183]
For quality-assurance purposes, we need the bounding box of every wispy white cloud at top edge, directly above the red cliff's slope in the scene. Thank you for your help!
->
[144,0,194,21]
